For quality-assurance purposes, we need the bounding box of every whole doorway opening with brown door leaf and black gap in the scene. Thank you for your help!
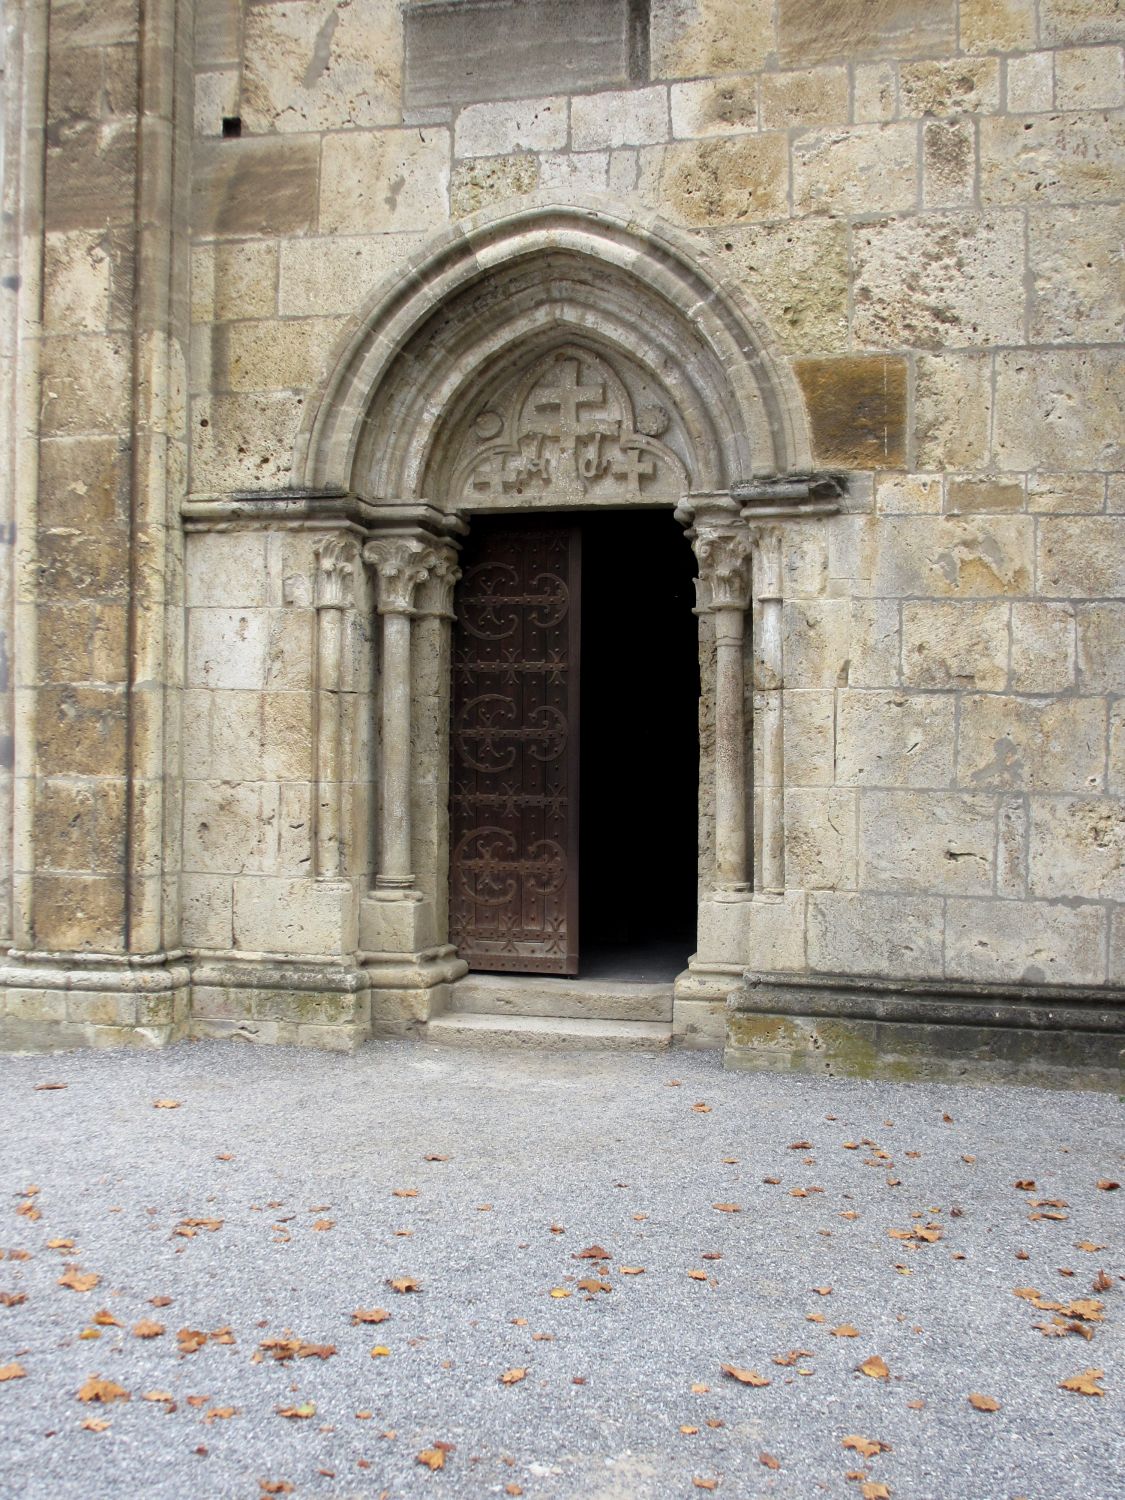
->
[450,509,699,983]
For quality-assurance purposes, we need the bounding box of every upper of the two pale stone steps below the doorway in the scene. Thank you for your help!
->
[449,974,672,1022]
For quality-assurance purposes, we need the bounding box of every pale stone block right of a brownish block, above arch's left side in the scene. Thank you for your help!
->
[320,128,449,234]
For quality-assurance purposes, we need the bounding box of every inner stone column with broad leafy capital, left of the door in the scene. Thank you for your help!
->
[363,537,438,894]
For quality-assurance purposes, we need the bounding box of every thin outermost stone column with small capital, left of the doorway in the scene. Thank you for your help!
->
[314,537,359,881]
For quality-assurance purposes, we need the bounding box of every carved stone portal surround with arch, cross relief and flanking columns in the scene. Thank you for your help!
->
[296,201,828,1044]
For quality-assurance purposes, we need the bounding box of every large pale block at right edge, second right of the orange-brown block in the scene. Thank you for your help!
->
[993,350,1125,470]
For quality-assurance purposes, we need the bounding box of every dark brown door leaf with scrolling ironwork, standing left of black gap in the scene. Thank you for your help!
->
[450,516,581,974]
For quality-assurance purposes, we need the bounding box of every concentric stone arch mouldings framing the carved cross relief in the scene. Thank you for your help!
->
[294,197,810,506]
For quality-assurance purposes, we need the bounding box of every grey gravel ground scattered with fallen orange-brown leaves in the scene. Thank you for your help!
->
[0,1043,1125,1500]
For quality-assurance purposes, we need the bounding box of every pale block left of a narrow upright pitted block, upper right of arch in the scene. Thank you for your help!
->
[794,125,918,213]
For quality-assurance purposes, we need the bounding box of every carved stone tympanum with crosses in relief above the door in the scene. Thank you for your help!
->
[453,347,687,507]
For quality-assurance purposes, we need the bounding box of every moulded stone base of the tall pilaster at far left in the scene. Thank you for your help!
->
[0,954,191,1052]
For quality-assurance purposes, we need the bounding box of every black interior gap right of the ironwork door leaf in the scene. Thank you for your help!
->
[579,510,699,980]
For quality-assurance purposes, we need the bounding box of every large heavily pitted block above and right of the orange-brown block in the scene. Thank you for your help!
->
[852,213,1025,350]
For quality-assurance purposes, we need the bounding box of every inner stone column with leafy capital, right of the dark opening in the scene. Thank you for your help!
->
[693,501,750,896]
